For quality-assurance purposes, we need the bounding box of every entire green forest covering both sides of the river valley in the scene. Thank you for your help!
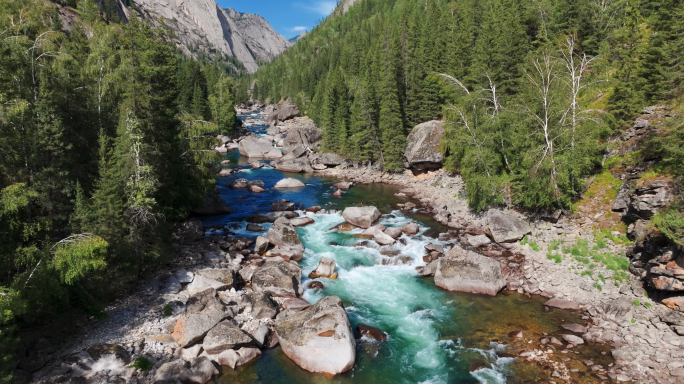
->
[0,0,684,383]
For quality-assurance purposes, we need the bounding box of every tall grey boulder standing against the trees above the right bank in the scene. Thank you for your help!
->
[404,120,444,170]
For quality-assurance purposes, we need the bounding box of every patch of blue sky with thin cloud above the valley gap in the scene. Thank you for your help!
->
[216,0,337,39]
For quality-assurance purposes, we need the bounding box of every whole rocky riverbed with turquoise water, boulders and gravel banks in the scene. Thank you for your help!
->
[24,107,684,384]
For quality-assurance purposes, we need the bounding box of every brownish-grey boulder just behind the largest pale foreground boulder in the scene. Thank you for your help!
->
[252,261,302,297]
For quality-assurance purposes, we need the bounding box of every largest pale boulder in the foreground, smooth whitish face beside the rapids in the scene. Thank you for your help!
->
[275,296,356,375]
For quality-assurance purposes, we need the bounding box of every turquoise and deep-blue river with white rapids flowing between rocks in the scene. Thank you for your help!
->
[204,115,610,384]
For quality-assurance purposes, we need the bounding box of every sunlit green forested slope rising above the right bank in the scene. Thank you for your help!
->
[254,0,684,209]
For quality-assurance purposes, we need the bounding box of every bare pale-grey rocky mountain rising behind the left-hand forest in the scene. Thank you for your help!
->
[132,0,291,73]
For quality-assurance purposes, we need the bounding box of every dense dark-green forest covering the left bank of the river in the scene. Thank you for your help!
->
[0,0,236,382]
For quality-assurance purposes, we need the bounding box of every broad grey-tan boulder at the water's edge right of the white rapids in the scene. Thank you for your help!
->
[435,246,506,296]
